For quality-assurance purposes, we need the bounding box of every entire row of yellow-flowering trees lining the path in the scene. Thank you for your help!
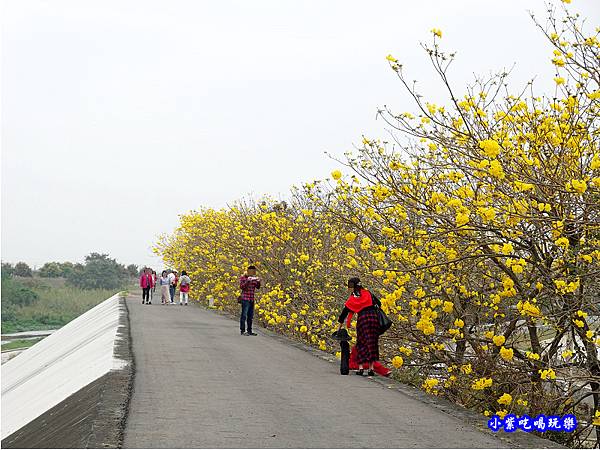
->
[156,3,600,445]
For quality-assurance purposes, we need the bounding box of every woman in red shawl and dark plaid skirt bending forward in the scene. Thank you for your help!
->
[338,277,381,376]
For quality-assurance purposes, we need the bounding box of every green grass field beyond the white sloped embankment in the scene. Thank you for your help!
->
[2,277,133,333]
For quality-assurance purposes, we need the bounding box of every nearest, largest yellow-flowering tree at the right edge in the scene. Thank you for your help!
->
[312,4,600,446]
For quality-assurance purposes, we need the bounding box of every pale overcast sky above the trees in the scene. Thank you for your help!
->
[0,0,600,268]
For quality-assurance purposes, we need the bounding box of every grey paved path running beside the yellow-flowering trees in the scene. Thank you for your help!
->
[124,295,504,448]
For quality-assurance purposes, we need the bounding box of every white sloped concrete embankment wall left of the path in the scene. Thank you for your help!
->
[1,295,127,439]
